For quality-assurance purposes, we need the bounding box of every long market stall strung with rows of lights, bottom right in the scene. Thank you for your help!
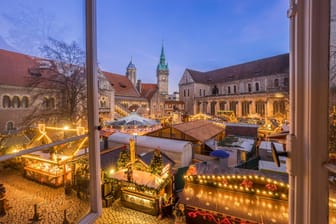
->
[179,164,289,224]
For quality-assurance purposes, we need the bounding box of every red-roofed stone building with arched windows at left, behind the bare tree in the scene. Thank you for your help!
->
[0,49,114,133]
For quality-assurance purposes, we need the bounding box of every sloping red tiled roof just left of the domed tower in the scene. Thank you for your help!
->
[103,71,140,97]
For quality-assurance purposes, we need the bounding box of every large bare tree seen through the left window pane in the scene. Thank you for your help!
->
[25,38,87,125]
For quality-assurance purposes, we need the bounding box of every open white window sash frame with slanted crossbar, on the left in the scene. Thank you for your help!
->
[0,0,102,224]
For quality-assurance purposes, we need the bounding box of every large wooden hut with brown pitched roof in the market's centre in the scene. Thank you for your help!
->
[146,120,224,154]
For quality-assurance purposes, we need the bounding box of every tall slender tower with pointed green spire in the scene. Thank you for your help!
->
[156,45,169,95]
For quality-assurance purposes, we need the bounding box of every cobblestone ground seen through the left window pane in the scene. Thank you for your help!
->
[0,170,89,224]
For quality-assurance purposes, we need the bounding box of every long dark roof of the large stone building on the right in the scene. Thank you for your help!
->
[187,54,289,83]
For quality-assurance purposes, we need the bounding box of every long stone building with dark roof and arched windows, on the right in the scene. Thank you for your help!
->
[179,54,289,120]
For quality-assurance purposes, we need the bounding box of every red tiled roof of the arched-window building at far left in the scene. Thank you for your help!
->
[0,49,38,86]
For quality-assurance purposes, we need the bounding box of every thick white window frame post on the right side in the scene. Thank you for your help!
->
[287,0,330,224]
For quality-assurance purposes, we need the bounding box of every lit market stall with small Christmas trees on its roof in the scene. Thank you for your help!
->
[109,146,173,215]
